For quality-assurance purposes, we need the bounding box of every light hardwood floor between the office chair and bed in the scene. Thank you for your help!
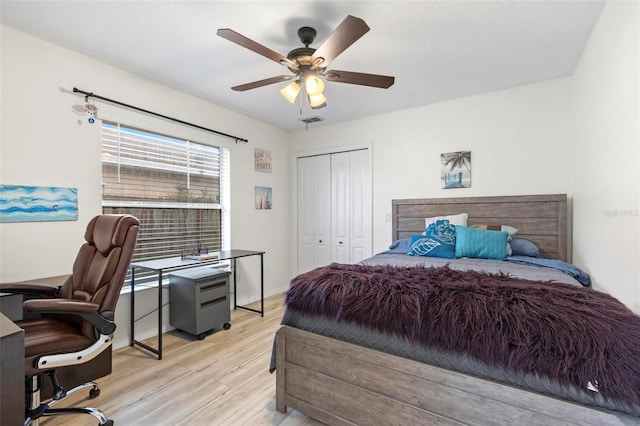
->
[41,295,320,426]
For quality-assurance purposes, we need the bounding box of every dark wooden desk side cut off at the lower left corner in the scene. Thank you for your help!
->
[0,313,24,426]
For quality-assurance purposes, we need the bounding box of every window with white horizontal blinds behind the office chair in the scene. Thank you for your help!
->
[102,121,229,270]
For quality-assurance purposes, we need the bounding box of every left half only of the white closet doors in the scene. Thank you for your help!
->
[297,155,331,273]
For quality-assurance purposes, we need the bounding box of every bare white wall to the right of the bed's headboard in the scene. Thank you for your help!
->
[572,1,640,312]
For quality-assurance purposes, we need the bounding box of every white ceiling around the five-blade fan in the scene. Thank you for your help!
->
[0,0,604,129]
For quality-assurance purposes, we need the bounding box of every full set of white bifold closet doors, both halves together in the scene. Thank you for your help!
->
[296,149,372,273]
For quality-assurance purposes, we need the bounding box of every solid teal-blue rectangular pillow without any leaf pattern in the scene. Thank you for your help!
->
[455,226,509,259]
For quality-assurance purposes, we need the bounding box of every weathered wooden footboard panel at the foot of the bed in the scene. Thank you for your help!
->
[276,326,640,425]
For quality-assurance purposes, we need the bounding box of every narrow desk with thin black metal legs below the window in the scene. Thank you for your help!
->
[129,250,265,360]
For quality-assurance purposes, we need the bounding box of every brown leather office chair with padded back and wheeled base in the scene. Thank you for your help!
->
[0,215,140,425]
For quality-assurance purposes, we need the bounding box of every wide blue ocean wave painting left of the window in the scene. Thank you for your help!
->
[0,185,78,223]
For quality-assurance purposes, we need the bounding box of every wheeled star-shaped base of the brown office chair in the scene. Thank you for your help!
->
[24,375,114,426]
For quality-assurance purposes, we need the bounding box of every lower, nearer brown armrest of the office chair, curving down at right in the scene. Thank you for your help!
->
[23,299,116,335]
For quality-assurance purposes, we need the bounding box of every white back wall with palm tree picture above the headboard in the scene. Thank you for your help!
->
[292,79,571,253]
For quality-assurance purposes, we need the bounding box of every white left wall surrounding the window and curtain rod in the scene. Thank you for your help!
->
[0,27,291,346]
